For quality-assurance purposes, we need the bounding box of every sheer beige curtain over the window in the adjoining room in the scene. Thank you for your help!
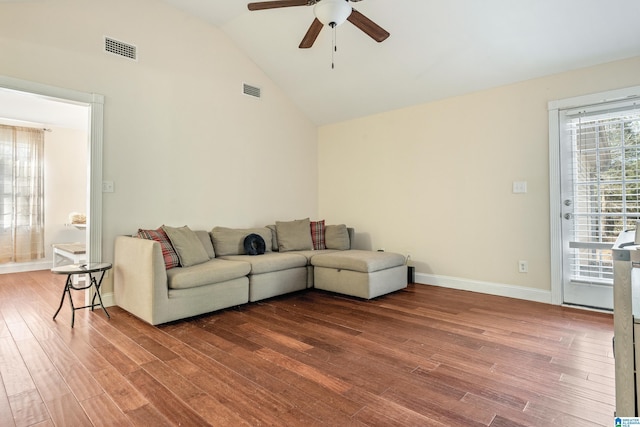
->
[0,125,44,263]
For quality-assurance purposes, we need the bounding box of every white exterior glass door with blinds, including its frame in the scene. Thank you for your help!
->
[550,88,640,310]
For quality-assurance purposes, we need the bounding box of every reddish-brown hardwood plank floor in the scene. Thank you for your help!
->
[0,271,615,427]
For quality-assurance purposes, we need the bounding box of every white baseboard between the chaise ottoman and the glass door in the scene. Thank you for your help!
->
[415,273,551,304]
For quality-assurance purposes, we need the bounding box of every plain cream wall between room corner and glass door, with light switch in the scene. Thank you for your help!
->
[318,57,640,298]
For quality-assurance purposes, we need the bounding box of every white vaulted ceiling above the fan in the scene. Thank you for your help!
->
[163,0,640,125]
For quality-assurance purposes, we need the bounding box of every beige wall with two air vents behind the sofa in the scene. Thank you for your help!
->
[0,0,318,284]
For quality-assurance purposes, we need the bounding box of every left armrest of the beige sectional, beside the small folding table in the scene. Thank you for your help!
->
[113,236,169,325]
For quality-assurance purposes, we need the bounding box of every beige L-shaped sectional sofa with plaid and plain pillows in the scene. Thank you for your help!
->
[114,219,407,325]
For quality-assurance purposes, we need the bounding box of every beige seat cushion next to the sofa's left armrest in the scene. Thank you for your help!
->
[167,258,251,289]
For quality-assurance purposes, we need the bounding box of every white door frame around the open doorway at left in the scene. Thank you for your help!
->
[0,75,104,262]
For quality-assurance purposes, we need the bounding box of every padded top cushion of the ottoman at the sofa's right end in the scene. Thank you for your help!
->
[311,250,405,273]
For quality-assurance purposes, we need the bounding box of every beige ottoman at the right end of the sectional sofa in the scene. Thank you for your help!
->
[311,250,407,299]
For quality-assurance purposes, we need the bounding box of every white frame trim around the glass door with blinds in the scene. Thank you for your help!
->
[548,86,640,305]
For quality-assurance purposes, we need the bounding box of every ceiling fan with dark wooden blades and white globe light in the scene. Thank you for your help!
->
[247,0,389,49]
